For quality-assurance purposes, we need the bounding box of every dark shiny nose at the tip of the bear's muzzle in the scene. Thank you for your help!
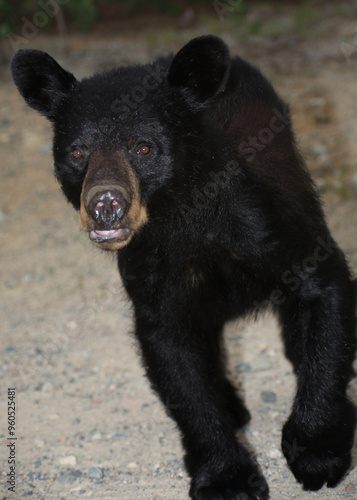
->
[87,187,128,229]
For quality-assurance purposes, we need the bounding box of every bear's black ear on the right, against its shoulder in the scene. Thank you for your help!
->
[168,35,231,103]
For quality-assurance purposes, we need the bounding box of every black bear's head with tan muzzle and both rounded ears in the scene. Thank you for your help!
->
[12,36,230,250]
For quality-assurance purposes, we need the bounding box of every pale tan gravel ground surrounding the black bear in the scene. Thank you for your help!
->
[0,2,357,500]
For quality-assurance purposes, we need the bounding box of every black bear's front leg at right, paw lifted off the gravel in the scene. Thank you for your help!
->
[281,264,356,490]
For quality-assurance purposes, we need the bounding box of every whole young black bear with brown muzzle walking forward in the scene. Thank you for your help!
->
[12,35,356,500]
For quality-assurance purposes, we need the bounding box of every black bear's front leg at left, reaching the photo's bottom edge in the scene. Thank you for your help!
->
[136,314,269,500]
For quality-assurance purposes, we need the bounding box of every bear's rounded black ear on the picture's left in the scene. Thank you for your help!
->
[11,49,77,119]
